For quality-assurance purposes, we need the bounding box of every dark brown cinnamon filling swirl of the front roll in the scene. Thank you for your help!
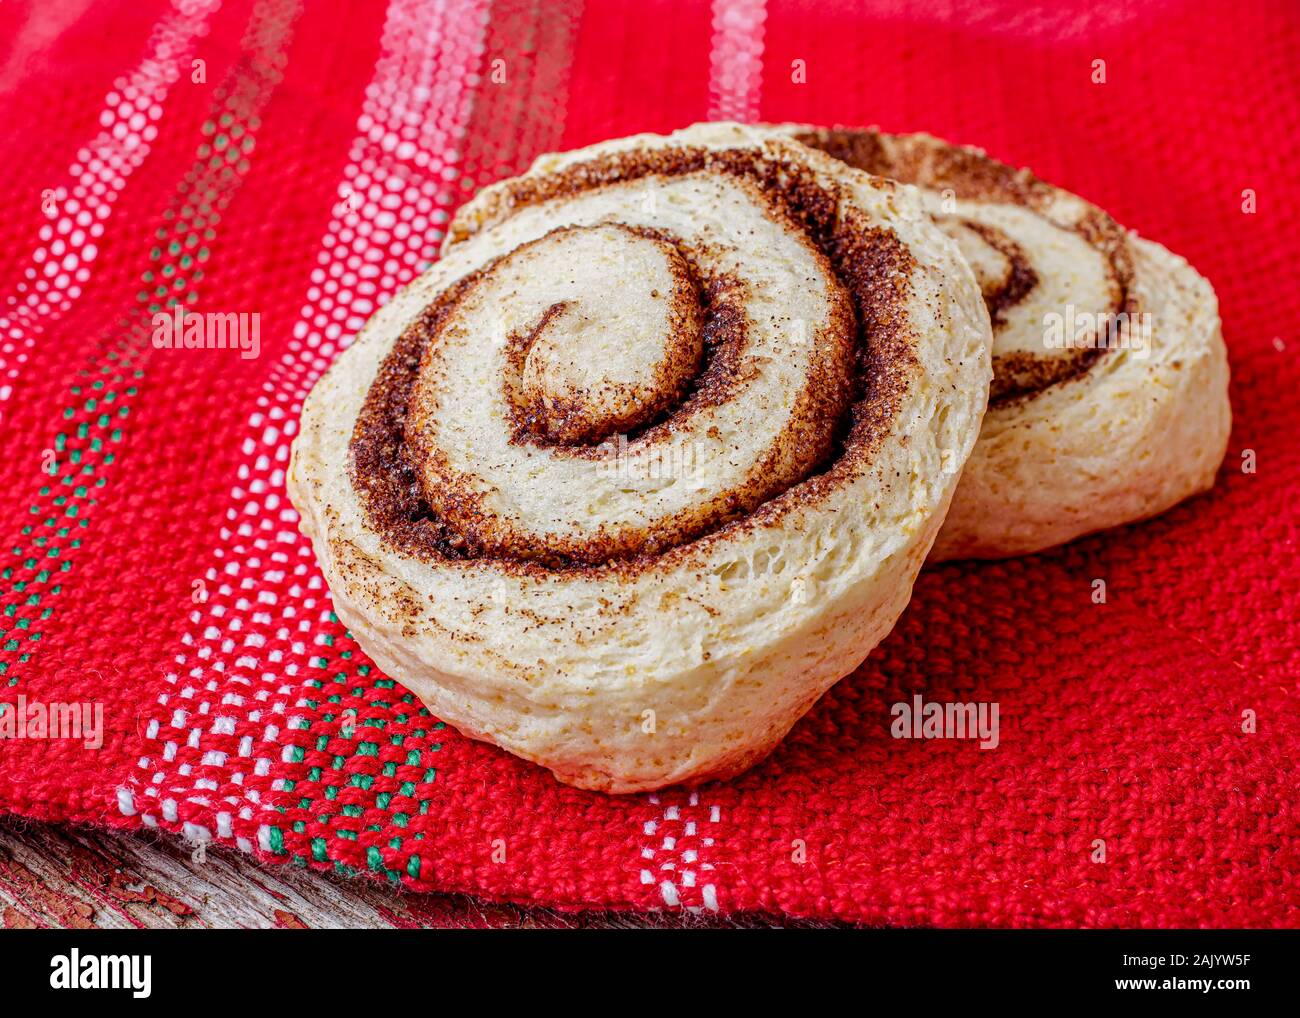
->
[350,150,915,572]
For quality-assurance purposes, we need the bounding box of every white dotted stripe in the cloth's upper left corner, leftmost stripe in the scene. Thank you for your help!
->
[0,0,221,402]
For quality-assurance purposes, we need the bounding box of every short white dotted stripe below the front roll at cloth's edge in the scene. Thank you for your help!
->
[641,792,722,913]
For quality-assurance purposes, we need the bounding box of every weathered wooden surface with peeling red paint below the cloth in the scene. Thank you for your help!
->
[0,816,821,928]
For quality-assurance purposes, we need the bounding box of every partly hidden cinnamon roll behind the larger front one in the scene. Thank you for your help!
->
[776,125,1231,560]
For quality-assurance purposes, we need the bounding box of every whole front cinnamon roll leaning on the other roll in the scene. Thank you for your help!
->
[289,125,991,792]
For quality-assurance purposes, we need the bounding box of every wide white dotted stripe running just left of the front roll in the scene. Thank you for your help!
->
[126,0,488,849]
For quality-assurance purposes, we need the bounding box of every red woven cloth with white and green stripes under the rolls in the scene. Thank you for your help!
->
[0,0,1300,926]
